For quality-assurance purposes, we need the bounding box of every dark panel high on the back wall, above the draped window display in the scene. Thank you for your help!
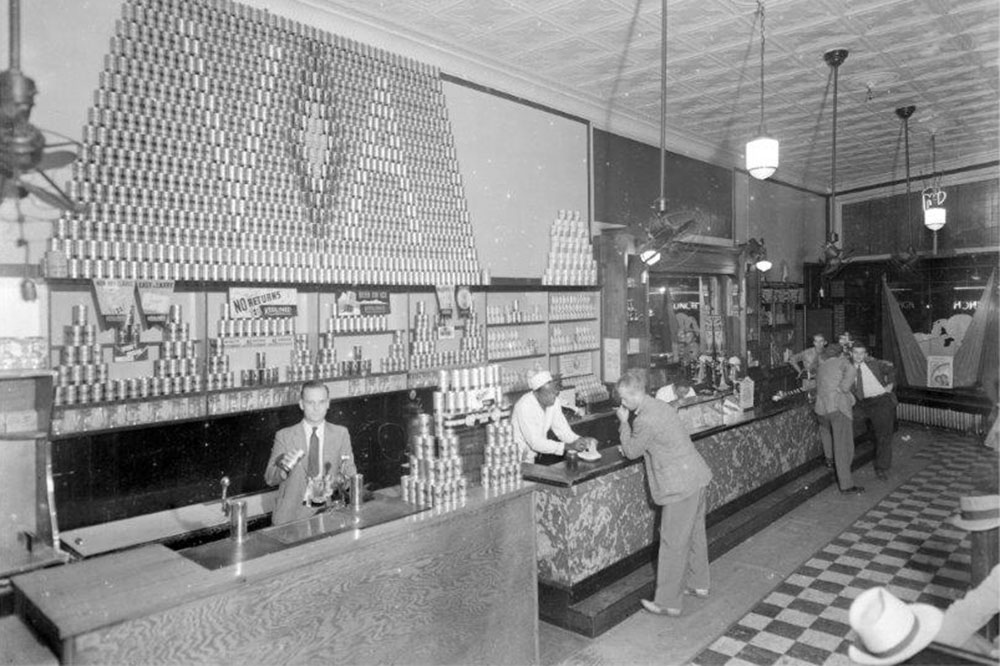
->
[841,179,1000,255]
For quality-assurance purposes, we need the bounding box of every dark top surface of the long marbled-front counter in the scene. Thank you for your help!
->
[521,400,808,487]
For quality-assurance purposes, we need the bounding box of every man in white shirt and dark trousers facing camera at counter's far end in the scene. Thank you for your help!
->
[851,342,899,481]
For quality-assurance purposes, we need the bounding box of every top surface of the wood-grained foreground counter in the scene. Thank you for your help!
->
[12,483,534,639]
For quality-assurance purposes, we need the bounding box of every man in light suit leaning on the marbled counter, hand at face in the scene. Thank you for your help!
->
[616,369,712,617]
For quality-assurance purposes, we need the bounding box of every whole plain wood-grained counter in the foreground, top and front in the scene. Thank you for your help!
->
[13,484,538,664]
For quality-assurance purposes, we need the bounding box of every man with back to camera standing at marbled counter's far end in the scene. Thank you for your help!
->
[813,345,865,494]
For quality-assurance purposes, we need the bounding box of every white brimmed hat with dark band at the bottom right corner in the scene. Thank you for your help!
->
[847,587,944,665]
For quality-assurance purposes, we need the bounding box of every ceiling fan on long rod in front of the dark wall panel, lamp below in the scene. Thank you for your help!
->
[639,0,700,266]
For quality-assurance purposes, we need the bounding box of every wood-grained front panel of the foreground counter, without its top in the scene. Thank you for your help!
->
[66,493,538,664]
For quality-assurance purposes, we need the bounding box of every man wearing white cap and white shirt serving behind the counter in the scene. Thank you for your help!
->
[510,370,596,462]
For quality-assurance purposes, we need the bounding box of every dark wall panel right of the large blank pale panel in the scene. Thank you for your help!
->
[594,129,733,240]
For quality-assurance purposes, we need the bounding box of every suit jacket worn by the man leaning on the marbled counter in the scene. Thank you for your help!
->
[618,395,712,504]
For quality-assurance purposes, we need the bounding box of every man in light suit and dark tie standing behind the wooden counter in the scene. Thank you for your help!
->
[264,382,357,525]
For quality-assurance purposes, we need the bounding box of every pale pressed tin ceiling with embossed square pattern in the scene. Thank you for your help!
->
[305,0,1000,191]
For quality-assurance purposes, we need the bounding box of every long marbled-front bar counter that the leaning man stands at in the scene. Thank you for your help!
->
[523,395,822,636]
